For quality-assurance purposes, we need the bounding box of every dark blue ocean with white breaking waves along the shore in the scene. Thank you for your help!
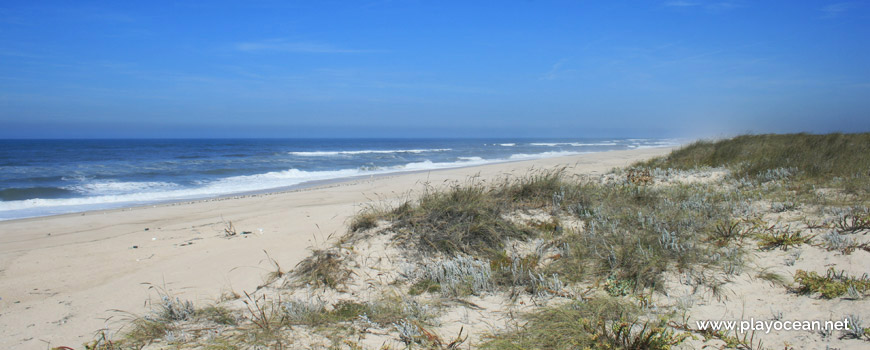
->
[0,139,680,220]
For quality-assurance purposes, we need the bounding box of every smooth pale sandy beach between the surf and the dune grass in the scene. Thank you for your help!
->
[0,148,670,349]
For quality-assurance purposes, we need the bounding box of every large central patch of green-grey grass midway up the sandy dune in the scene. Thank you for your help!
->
[355,165,743,293]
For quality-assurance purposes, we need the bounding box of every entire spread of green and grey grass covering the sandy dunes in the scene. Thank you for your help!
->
[87,134,870,349]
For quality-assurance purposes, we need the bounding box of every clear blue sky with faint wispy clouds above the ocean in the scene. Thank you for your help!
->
[0,0,870,138]
